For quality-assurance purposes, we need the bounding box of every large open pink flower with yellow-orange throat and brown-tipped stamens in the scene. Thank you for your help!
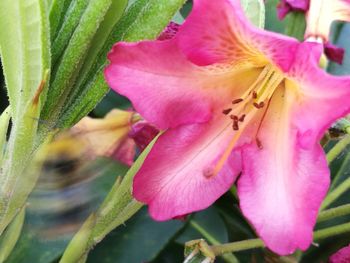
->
[105,0,350,255]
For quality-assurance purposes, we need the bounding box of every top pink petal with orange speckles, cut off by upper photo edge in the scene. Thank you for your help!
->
[175,0,298,70]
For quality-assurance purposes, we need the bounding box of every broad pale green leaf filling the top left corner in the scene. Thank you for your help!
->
[0,0,50,122]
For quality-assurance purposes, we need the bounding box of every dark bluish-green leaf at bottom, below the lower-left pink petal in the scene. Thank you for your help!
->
[87,208,184,263]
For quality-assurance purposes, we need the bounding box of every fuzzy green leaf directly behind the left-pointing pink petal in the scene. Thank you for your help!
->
[58,0,185,128]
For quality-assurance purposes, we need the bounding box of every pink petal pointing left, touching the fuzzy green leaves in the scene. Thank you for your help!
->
[105,39,258,129]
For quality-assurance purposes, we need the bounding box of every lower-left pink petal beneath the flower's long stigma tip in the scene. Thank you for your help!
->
[133,117,241,220]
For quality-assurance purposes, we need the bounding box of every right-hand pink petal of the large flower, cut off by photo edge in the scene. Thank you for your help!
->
[286,43,350,147]
